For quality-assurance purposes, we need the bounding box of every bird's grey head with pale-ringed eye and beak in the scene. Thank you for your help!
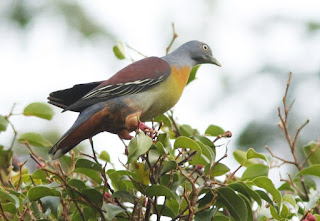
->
[166,41,221,66]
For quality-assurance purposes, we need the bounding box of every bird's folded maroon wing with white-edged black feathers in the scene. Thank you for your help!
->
[64,57,171,111]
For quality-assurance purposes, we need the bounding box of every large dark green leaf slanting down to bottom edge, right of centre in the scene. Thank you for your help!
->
[217,187,251,221]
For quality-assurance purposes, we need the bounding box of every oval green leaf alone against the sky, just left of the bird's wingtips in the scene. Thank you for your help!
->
[23,102,54,120]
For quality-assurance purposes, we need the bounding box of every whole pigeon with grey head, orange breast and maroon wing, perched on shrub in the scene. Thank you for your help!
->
[48,40,221,160]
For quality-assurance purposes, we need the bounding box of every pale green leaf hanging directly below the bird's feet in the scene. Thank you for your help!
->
[128,132,153,163]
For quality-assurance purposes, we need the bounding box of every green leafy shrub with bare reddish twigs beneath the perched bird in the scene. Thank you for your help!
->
[0,54,320,221]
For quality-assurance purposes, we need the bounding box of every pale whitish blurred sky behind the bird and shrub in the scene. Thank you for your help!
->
[0,0,320,195]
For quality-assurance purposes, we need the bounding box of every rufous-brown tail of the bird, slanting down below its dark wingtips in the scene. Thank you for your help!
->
[49,104,104,160]
